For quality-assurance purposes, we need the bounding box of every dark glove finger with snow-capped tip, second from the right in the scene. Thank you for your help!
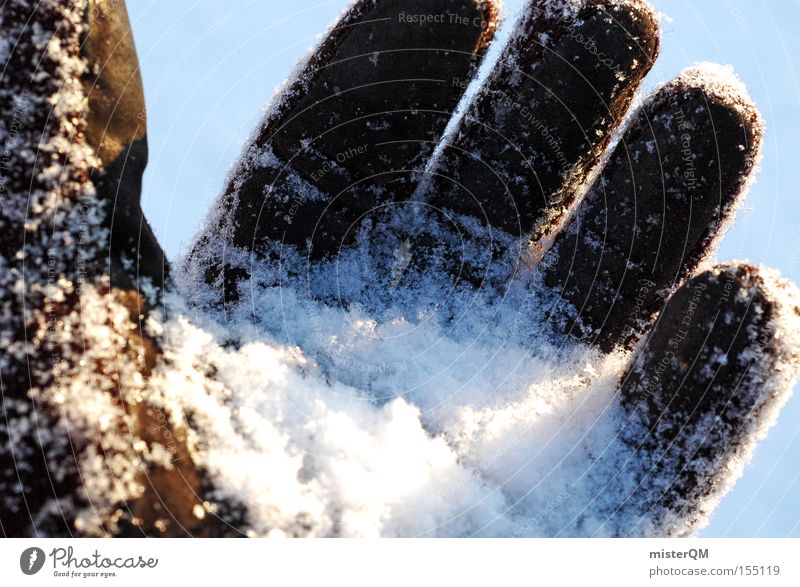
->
[544,65,763,351]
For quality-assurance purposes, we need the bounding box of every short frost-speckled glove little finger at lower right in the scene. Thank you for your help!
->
[609,264,800,536]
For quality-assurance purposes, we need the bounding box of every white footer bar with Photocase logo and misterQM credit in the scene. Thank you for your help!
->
[0,539,800,587]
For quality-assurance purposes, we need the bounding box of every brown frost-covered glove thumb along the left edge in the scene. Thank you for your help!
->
[0,0,228,536]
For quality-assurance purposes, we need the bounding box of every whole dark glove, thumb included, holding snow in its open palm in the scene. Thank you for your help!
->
[0,0,800,536]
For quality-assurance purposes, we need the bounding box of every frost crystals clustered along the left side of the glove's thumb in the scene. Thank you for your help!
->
[0,0,160,535]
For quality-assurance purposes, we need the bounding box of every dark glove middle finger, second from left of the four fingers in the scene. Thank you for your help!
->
[424,0,659,284]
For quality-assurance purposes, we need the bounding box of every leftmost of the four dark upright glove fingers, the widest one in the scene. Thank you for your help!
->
[190,0,497,299]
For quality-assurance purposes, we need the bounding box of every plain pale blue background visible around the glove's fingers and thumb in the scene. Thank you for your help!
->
[127,0,800,536]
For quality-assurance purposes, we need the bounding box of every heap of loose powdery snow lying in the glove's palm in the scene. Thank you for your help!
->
[170,1,791,536]
